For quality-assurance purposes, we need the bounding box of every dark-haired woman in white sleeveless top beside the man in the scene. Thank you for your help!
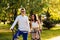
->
[30,14,40,40]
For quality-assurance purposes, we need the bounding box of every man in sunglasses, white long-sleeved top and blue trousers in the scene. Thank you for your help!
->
[10,8,30,40]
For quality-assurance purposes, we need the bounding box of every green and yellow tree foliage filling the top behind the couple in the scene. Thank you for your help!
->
[0,0,60,23]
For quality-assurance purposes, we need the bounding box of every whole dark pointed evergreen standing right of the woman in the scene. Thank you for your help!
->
[43,9,54,29]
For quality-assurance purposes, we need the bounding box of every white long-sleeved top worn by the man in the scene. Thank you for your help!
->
[11,15,30,32]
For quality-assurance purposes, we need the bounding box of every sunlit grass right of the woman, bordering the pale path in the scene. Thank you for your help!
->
[41,29,60,40]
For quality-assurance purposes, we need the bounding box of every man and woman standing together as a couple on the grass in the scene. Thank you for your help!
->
[10,8,41,40]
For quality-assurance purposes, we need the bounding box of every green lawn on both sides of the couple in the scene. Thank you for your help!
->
[0,25,60,40]
